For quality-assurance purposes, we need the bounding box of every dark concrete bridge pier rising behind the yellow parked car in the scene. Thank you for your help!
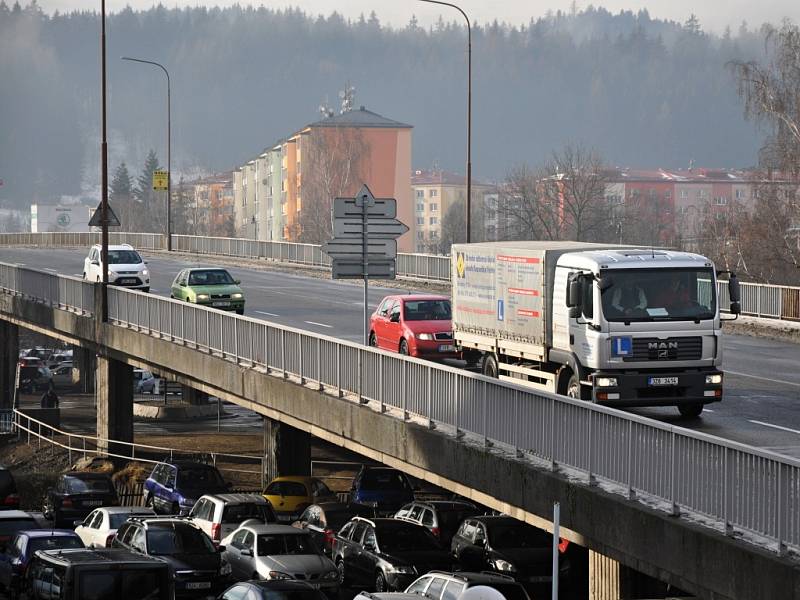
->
[264,417,311,483]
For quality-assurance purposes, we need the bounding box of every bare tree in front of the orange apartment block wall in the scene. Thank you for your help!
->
[299,127,370,244]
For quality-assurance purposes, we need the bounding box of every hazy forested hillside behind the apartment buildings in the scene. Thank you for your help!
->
[0,2,763,206]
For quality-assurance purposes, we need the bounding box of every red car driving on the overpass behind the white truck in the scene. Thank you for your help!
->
[369,295,459,360]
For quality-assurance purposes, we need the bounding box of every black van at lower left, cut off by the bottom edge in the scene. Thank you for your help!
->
[24,548,174,600]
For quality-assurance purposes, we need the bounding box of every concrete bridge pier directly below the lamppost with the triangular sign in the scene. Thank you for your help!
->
[97,356,133,456]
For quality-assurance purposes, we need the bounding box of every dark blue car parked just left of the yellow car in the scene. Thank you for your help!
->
[144,461,229,515]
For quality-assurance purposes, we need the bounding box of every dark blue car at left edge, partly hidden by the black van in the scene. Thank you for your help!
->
[0,529,84,598]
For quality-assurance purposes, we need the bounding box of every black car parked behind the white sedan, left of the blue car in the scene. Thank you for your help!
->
[42,471,119,527]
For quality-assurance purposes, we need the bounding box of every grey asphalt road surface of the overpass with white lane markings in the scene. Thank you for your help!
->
[0,248,800,458]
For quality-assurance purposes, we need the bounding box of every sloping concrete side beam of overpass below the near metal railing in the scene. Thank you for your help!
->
[0,295,800,600]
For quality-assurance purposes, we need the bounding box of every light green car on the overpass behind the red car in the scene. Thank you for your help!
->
[170,267,244,315]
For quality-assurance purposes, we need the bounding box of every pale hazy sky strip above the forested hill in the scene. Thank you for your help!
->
[31,0,800,31]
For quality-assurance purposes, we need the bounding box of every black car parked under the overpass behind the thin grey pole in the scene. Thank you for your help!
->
[450,516,569,583]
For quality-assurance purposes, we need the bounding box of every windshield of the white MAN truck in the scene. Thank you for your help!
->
[601,268,716,321]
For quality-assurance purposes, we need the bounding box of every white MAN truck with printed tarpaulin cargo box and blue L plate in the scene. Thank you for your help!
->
[452,242,739,417]
